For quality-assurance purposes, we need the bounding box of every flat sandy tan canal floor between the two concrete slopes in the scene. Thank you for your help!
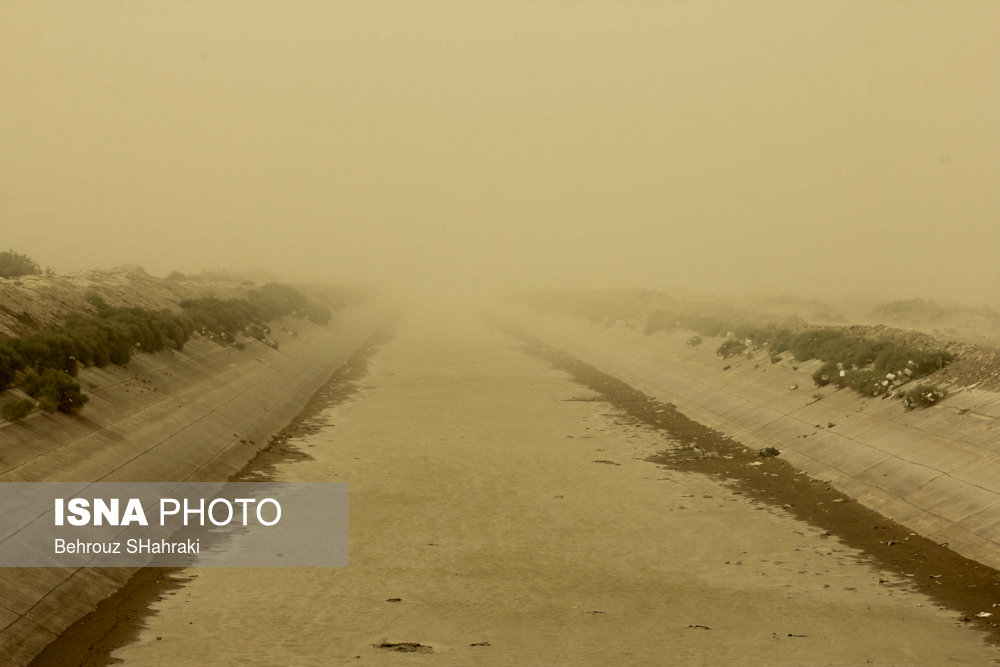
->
[113,314,997,665]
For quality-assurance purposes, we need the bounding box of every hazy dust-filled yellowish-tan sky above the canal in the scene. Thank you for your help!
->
[0,0,1000,303]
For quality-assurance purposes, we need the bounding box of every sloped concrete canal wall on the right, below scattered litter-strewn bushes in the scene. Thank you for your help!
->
[514,311,1000,568]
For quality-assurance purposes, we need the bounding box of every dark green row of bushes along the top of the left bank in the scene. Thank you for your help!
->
[0,283,330,418]
